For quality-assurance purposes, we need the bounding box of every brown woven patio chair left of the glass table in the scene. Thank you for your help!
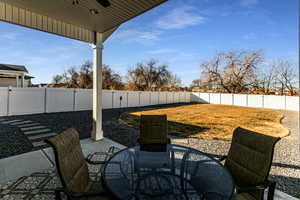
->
[46,128,118,200]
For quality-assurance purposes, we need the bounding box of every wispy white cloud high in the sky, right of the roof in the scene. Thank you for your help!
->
[156,6,205,29]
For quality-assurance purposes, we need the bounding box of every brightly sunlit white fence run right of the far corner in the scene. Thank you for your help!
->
[190,92,299,111]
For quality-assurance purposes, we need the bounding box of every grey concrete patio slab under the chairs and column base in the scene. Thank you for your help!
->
[0,138,298,200]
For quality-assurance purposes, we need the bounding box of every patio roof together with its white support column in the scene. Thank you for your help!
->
[0,0,166,140]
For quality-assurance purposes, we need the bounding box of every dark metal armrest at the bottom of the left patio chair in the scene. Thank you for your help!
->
[55,188,108,200]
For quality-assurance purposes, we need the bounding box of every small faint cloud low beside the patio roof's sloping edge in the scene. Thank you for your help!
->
[113,29,160,43]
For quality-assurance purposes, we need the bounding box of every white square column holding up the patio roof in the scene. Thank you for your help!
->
[92,33,103,140]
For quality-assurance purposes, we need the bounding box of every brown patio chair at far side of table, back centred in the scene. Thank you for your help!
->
[138,115,170,152]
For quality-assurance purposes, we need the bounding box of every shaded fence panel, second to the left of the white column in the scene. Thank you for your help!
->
[46,88,74,113]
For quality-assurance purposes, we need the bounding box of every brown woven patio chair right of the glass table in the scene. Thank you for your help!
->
[221,127,280,200]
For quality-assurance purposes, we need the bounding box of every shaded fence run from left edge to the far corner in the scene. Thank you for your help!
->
[0,87,190,116]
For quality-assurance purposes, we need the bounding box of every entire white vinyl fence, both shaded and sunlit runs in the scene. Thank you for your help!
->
[0,87,299,116]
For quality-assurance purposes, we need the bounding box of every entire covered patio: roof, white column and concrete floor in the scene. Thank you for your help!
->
[0,0,294,200]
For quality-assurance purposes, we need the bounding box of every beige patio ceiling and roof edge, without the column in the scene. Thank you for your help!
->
[0,0,166,43]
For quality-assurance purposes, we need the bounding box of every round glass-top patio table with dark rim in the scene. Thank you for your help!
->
[102,144,234,200]
